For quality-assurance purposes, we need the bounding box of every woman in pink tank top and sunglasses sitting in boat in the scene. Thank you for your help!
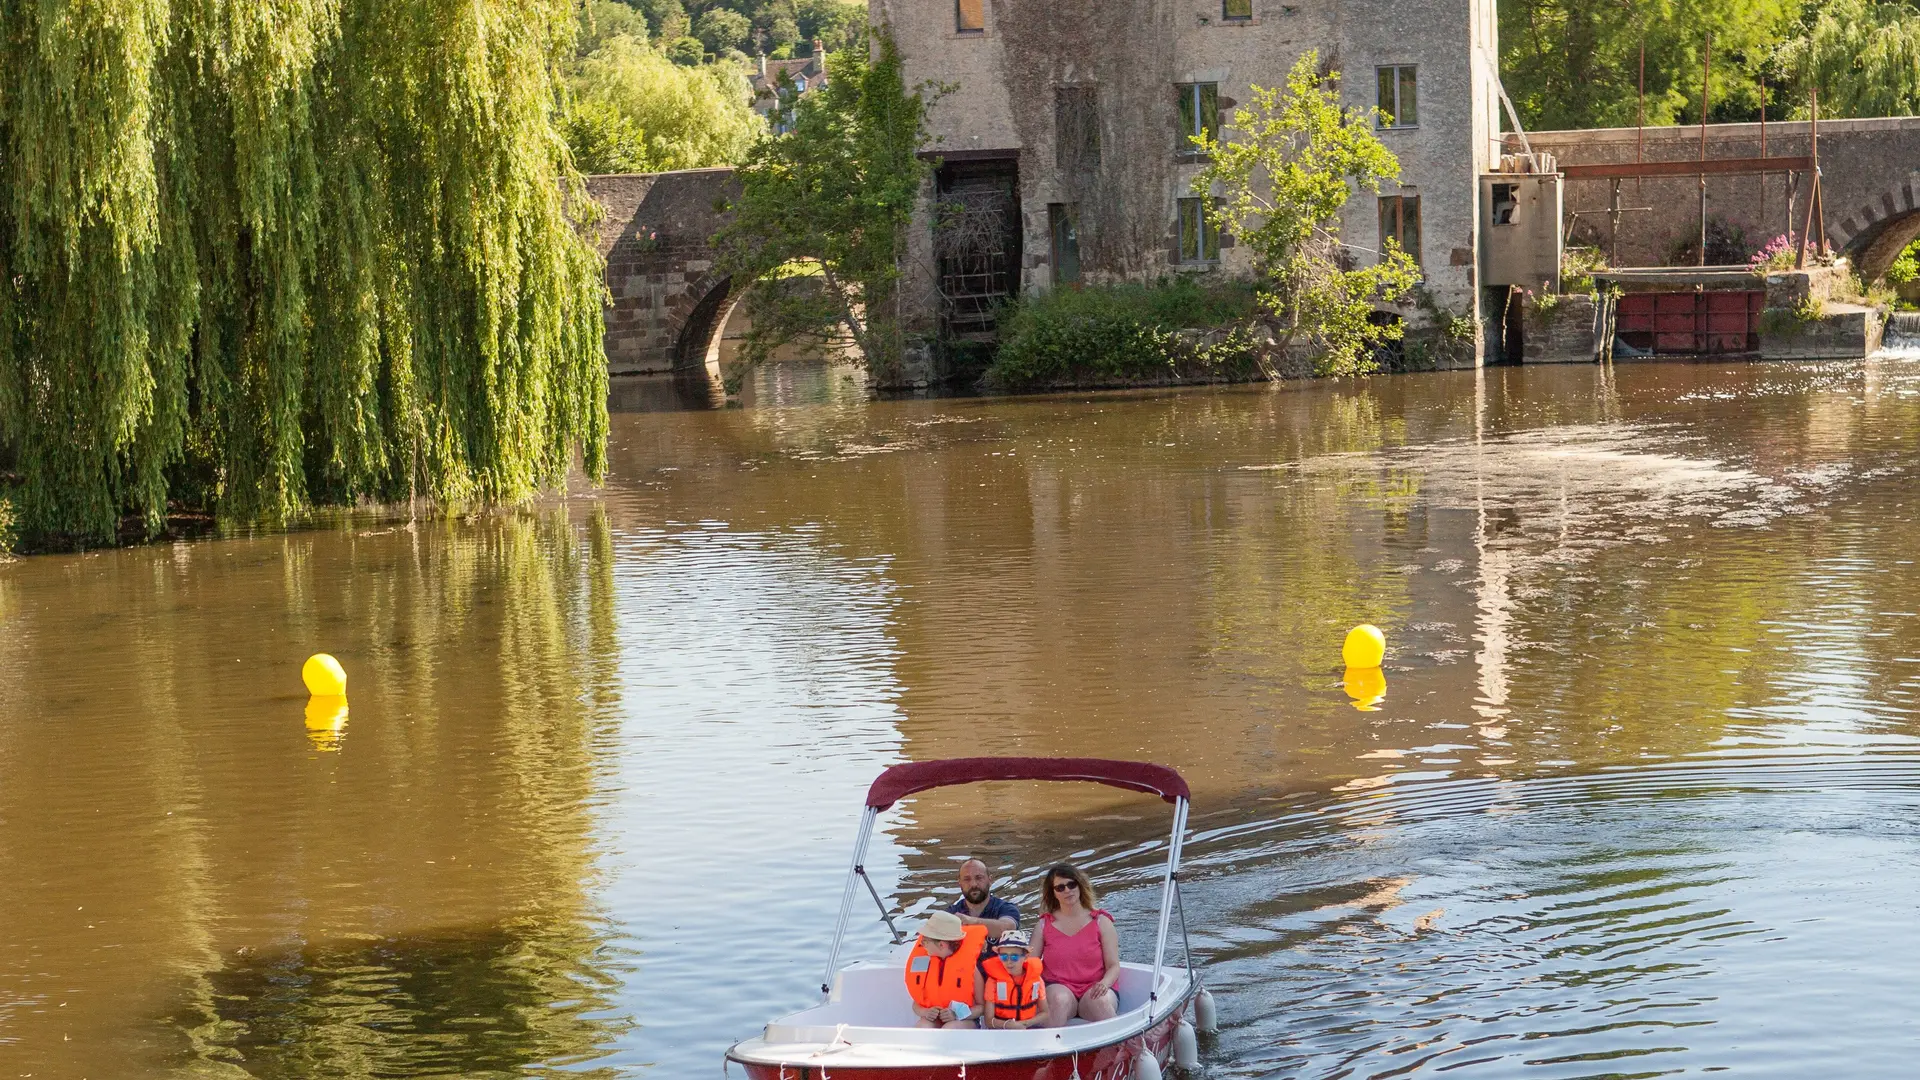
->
[1031,863,1119,1028]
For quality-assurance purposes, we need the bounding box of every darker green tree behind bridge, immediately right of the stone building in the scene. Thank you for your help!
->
[1500,0,1797,129]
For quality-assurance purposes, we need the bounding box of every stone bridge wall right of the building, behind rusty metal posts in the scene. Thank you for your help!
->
[1505,117,1920,279]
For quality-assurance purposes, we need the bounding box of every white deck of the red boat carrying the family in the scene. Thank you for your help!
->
[732,949,1190,1068]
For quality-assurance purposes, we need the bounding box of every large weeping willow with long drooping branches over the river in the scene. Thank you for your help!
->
[0,0,607,544]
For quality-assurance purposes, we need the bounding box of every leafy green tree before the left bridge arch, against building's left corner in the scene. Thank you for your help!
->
[714,38,929,373]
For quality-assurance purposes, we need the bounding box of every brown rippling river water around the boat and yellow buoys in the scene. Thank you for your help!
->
[0,356,1920,1080]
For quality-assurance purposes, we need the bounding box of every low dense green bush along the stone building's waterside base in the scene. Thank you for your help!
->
[987,277,1260,390]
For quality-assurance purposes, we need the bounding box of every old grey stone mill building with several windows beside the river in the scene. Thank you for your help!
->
[870,0,1500,365]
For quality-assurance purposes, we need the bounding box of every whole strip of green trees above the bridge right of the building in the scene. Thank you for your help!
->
[1500,0,1920,129]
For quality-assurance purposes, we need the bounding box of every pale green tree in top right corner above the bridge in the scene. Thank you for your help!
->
[1780,0,1920,117]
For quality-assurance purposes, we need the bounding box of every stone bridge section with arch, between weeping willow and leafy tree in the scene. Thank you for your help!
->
[588,169,739,375]
